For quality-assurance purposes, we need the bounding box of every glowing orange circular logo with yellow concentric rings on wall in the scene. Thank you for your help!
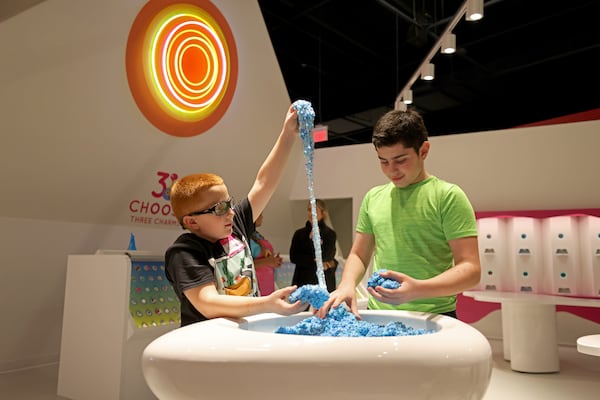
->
[126,0,238,137]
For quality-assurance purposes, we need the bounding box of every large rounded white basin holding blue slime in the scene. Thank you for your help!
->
[142,310,492,400]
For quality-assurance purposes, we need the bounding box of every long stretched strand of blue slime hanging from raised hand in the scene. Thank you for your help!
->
[293,100,327,290]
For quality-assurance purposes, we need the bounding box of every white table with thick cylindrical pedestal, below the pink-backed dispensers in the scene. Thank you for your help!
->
[463,291,600,373]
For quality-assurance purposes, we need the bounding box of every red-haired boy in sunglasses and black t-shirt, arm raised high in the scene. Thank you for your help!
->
[165,105,305,326]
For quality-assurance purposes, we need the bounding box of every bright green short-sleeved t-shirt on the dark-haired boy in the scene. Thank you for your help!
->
[356,176,477,313]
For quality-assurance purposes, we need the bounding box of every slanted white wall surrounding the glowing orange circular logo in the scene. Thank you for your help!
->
[0,0,302,371]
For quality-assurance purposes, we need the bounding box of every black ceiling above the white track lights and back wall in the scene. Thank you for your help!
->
[258,0,600,147]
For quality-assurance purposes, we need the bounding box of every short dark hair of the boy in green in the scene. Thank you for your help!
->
[371,110,428,153]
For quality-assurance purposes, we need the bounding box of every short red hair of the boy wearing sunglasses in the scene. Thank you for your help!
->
[170,173,225,226]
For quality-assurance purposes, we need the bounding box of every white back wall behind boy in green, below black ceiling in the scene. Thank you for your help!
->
[290,121,600,225]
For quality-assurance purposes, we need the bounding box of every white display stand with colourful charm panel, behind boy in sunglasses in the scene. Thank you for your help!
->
[57,250,181,400]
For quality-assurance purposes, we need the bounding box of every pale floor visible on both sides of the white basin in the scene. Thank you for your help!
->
[0,340,600,400]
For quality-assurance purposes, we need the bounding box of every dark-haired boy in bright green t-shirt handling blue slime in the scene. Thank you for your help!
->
[317,110,481,318]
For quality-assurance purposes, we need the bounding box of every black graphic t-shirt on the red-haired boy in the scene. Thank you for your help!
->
[165,198,258,326]
